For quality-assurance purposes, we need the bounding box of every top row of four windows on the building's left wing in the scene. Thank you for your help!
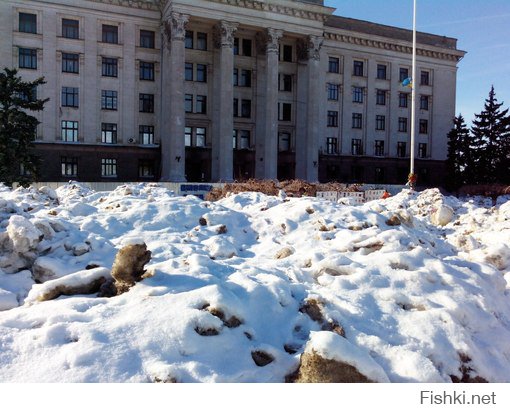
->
[18,12,156,49]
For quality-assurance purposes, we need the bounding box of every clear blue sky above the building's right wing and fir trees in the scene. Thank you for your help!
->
[324,0,510,124]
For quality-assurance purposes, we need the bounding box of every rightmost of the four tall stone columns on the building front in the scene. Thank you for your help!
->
[296,36,326,182]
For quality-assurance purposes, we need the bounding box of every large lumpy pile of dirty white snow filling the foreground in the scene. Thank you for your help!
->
[0,183,510,382]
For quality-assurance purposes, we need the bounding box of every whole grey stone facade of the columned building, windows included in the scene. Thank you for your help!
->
[0,0,464,184]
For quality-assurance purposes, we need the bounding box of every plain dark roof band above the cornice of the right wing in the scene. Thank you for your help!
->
[325,15,457,50]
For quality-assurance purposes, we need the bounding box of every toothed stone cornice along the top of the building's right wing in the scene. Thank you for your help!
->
[324,32,465,62]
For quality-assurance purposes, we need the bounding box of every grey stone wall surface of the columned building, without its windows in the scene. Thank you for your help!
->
[0,0,464,183]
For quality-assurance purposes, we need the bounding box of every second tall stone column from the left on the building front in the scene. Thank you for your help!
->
[211,21,237,182]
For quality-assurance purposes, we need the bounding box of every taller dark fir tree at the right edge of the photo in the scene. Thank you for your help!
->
[471,86,510,183]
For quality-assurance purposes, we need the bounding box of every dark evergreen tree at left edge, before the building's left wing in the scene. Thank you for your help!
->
[0,68,48,186]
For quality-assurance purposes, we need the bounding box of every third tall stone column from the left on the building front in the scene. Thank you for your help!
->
[255,28,283,179]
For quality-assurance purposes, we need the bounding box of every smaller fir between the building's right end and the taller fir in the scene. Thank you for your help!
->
[446,114,473,190]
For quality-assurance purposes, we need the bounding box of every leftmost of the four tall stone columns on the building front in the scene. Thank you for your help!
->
[161,12,189,182]
